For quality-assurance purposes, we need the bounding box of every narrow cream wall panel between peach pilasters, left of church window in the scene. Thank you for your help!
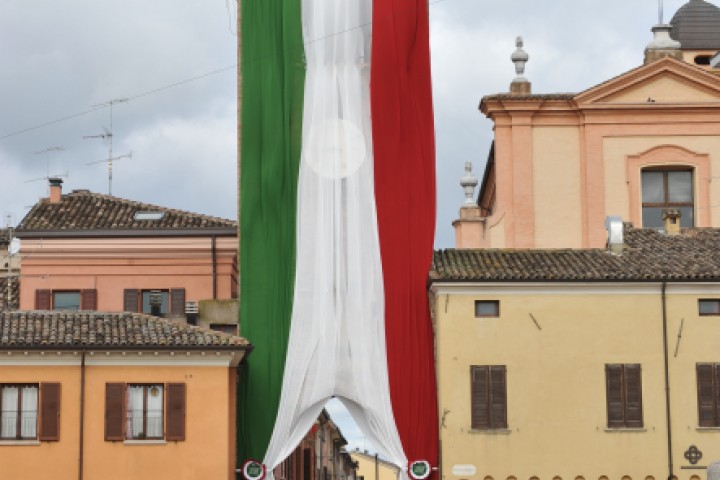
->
[533,126,582,248]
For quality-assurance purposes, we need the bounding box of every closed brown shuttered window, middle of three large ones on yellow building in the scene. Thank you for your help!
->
[605,364,643,428]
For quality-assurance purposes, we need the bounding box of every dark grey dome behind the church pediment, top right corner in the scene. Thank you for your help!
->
[670,0,720,50]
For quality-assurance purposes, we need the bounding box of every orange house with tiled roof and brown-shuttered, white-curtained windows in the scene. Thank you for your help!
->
[0,311,252,480]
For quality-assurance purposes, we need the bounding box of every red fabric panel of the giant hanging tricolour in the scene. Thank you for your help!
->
[370,0,438,466]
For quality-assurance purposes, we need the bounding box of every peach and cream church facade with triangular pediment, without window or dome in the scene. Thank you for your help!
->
[478,59,720,248]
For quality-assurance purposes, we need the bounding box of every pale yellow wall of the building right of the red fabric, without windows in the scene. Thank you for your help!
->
[433,284,720,480]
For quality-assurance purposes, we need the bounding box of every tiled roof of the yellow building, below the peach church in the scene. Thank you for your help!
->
[430,229,720,282]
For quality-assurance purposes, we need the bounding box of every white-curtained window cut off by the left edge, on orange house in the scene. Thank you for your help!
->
[0,385,38,440]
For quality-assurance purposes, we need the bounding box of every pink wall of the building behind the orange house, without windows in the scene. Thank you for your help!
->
[20,237,238,312]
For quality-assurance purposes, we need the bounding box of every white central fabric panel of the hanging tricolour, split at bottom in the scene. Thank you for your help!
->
[264,0,407,476]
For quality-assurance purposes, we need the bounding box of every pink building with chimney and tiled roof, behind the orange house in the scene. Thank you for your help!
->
[16,179,238,321]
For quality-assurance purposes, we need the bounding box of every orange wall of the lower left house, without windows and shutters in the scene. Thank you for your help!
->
[0,352,235,480]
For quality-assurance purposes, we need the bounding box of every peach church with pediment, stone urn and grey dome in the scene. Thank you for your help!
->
[455,1,720,248]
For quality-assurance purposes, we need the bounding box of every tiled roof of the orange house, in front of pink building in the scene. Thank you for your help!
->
[0,311,252,350]
